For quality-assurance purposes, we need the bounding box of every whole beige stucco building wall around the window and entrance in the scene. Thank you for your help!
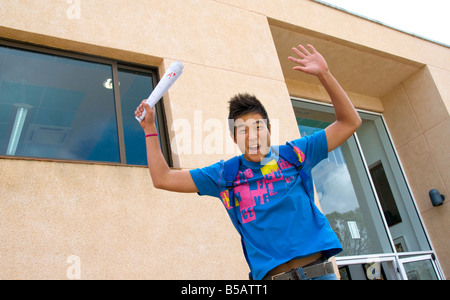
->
[0,0,450,279]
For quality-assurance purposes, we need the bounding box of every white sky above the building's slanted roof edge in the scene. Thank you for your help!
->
[319,0,450,46]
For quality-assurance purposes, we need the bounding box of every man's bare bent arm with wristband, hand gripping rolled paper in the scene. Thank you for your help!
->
[134,100,198,193]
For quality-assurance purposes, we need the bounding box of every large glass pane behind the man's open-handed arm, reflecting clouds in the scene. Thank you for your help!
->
[293,102,393,256]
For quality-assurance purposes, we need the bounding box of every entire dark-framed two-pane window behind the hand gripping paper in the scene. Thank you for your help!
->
[0,42,169,165]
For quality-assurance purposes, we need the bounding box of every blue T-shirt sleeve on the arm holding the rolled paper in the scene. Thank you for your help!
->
[189,161,224,198]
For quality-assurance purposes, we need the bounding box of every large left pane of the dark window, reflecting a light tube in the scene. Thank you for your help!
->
[0,46,120,162]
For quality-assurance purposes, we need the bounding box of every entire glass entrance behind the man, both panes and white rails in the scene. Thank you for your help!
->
[292,99,440,279]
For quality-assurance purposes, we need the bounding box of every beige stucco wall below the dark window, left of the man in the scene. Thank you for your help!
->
[0,159,247,279]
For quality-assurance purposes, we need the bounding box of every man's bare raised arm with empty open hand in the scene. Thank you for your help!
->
[289,45,362,151]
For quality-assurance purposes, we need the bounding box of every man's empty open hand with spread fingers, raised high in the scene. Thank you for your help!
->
[288,45,329,76]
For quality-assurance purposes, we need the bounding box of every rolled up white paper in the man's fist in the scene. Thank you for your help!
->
[136,61,184,122]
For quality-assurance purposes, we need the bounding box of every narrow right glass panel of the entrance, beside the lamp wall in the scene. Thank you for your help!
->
[356,113,431,252]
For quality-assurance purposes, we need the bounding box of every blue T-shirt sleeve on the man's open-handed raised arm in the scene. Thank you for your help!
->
[292,130,328,168]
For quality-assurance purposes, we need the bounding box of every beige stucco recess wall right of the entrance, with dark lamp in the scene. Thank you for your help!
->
[382,67,450,274]
